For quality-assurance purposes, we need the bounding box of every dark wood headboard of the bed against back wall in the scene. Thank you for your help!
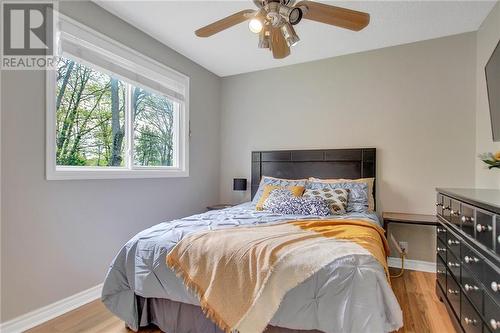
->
[251,148,377,199]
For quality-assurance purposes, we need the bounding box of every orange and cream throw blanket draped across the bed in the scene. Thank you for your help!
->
[167,219,389,333]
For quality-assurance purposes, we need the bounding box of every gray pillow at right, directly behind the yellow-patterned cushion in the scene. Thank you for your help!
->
[307,182,368,213]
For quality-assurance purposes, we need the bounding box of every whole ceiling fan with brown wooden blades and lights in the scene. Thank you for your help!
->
[195,0,370,59]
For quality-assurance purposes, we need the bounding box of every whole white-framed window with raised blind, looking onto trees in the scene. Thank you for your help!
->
[47,15,189,179]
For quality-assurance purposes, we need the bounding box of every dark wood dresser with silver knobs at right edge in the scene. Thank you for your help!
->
[436,188,500,333]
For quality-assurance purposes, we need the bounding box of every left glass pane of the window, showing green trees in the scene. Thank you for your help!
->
[56,57,129,167]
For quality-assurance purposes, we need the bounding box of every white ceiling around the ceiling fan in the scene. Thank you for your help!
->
[95,0,496,76]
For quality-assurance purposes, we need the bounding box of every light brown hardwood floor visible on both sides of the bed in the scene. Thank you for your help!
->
[27,271,454,333]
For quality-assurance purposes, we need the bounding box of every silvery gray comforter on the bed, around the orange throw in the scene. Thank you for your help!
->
[102,203,403,333]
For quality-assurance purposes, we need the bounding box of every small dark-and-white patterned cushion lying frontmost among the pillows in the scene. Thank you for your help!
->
[264,189,330,216]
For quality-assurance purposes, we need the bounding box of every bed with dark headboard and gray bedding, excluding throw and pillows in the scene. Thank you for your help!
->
[102,148,402,333]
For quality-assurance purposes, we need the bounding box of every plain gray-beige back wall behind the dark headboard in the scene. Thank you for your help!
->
[220,33,476,261]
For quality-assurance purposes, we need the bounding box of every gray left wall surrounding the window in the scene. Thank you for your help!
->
[1,2,221,321]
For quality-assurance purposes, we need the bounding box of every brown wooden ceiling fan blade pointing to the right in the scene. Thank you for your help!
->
[295,1,370,31]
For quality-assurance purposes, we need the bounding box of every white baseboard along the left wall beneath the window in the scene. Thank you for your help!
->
[0,284,102,333]
